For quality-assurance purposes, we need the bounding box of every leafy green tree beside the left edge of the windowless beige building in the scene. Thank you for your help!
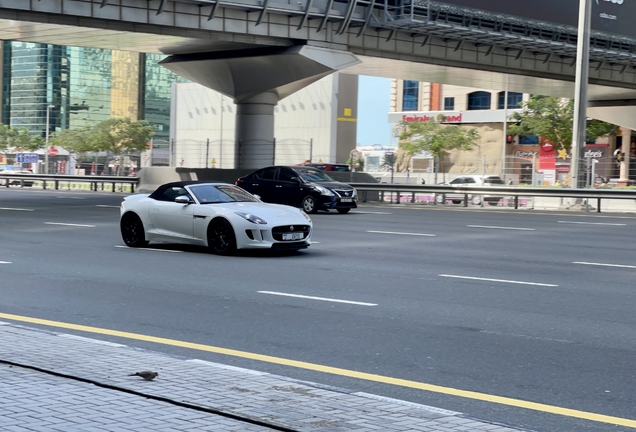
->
[88,118,155,174]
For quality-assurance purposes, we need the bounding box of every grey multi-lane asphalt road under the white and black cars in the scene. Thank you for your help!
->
[0,188,636,432]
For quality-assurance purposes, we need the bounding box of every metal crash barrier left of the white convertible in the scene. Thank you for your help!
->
[0,173,139,193]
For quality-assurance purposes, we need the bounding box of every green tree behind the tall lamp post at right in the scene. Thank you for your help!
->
[508,96,618,152]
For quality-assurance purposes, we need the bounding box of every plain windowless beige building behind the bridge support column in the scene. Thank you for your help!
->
[170,73,358,168]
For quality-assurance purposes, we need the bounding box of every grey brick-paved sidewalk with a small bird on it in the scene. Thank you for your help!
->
[0,322,536,432]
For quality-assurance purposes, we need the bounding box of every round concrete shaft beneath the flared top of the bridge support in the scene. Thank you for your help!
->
[236,92,278,168]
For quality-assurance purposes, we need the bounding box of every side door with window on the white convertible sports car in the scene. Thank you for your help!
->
[150,187,196,239]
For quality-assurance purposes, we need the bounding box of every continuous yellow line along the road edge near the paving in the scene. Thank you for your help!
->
[0,312,636,428]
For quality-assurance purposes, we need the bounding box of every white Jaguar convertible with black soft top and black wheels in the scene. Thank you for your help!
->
[119,181,313,255]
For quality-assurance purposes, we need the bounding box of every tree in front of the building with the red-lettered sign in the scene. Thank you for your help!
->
[399,119,480,182]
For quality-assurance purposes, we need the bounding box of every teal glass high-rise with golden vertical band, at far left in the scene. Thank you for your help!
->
[0,42,184,164]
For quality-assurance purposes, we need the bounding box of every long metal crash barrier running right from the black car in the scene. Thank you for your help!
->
[348,183,636,213]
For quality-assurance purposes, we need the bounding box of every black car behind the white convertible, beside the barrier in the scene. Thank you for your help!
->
[236,166,358,213]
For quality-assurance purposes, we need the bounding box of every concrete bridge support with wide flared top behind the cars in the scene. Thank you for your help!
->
[160,45,360,168]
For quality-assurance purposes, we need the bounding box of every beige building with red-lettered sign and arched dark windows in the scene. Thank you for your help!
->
[389,80,622,185]
